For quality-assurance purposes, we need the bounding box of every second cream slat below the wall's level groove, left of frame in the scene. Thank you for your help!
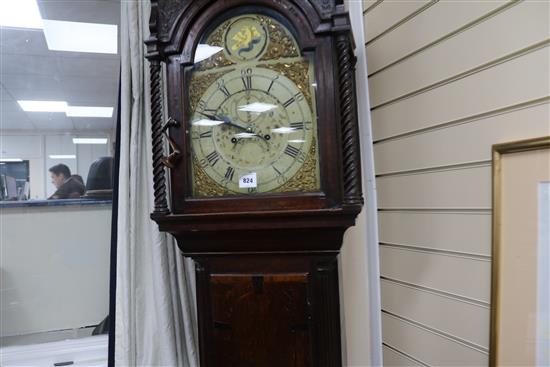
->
[380,246,491,302]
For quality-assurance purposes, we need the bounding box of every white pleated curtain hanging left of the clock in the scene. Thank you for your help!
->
[115,1,198,366]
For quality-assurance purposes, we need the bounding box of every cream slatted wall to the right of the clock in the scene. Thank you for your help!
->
[363,0,550,366]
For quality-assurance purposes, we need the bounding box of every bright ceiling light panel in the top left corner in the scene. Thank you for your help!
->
[0,0,43,29]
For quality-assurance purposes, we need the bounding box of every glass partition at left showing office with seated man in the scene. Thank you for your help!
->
[0,0,120,366]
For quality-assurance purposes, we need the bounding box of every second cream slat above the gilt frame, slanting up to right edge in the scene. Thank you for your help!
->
[372,47,550,140]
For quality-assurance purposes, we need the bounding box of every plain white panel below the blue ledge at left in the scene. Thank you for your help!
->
[0,205,111,336]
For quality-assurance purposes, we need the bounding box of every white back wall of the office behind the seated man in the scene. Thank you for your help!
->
[0,130,112,199]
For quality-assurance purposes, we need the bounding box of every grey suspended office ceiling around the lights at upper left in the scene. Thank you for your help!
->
[0,0,120,131]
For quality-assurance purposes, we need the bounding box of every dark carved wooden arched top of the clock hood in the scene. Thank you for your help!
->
[145,0,351,63]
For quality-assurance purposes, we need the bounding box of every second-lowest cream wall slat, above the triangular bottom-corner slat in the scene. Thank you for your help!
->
[382,314,489,366]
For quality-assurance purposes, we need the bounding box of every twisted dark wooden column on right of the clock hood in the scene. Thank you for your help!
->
[336,34,363,205]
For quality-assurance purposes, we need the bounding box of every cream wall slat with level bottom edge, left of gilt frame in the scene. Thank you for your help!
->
[376,165,491,209]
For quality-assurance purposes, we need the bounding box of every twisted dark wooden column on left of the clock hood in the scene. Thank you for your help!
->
[149,60,170,214]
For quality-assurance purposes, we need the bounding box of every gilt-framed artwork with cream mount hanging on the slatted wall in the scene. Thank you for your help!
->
[490,136,550,366]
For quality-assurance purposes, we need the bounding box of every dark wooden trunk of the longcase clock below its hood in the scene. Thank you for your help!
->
[178,228,345,367]
